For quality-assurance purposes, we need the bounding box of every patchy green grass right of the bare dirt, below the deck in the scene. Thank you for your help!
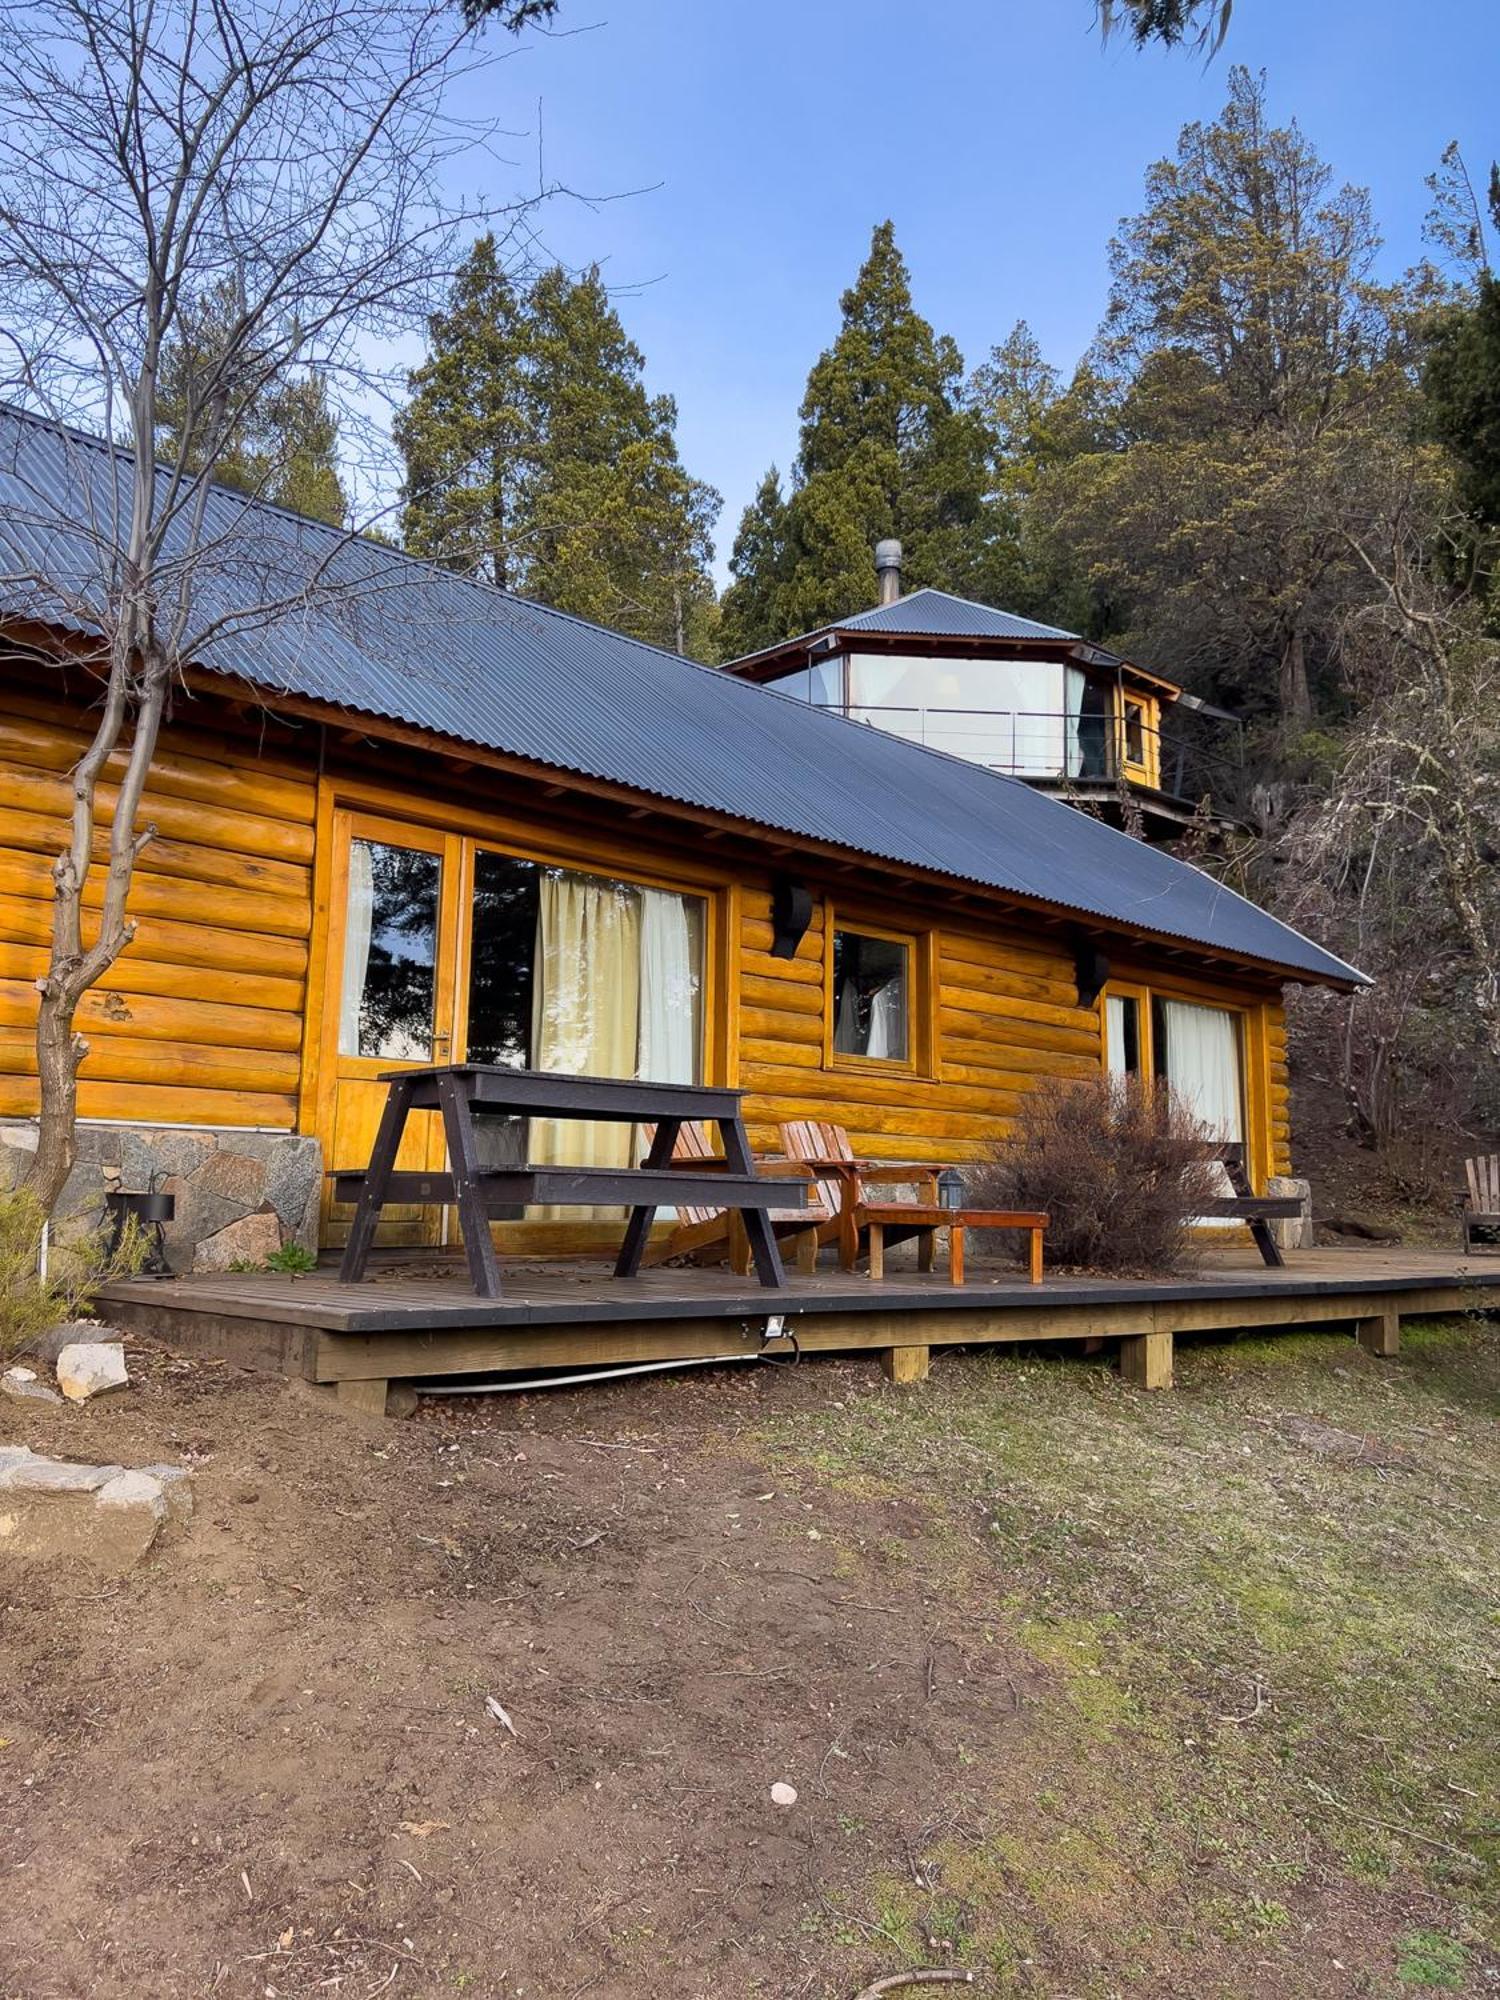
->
[762,1320,1500,1992]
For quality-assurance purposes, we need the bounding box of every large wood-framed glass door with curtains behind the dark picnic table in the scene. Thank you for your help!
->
[324,812,708,1242]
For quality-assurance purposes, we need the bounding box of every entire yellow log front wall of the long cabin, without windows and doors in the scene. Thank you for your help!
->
[0,672,1290,1200]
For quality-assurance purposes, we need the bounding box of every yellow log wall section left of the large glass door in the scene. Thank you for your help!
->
[0,696,316,1128]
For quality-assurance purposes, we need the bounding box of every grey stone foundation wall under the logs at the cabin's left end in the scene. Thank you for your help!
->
[0,1122,322,1270]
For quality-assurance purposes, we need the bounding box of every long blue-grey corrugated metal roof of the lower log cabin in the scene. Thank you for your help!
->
[0,408,1360,984]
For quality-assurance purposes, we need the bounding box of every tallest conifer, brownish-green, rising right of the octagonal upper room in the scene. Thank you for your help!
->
[1036,68,1432,738]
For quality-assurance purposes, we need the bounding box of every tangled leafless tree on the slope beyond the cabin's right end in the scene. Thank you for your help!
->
[1278,486,1500,1156]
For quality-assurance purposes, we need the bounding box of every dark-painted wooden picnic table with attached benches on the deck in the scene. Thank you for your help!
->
[334,1062,806,1298]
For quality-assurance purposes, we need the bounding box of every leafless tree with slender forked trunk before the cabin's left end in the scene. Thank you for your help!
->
[0,0,540,1210]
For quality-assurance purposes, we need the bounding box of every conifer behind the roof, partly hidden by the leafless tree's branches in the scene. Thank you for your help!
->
[156,282,348,528]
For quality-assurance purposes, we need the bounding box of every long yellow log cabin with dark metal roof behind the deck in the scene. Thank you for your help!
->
[0,410,1360,1270]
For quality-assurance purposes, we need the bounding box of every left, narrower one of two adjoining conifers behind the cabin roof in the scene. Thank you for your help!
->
[394,236,536,588]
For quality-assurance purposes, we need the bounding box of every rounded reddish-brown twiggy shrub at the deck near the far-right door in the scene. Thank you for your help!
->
[966,1076,1224,1276]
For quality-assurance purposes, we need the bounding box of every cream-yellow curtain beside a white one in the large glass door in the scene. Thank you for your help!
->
[528,872,640,1222]
